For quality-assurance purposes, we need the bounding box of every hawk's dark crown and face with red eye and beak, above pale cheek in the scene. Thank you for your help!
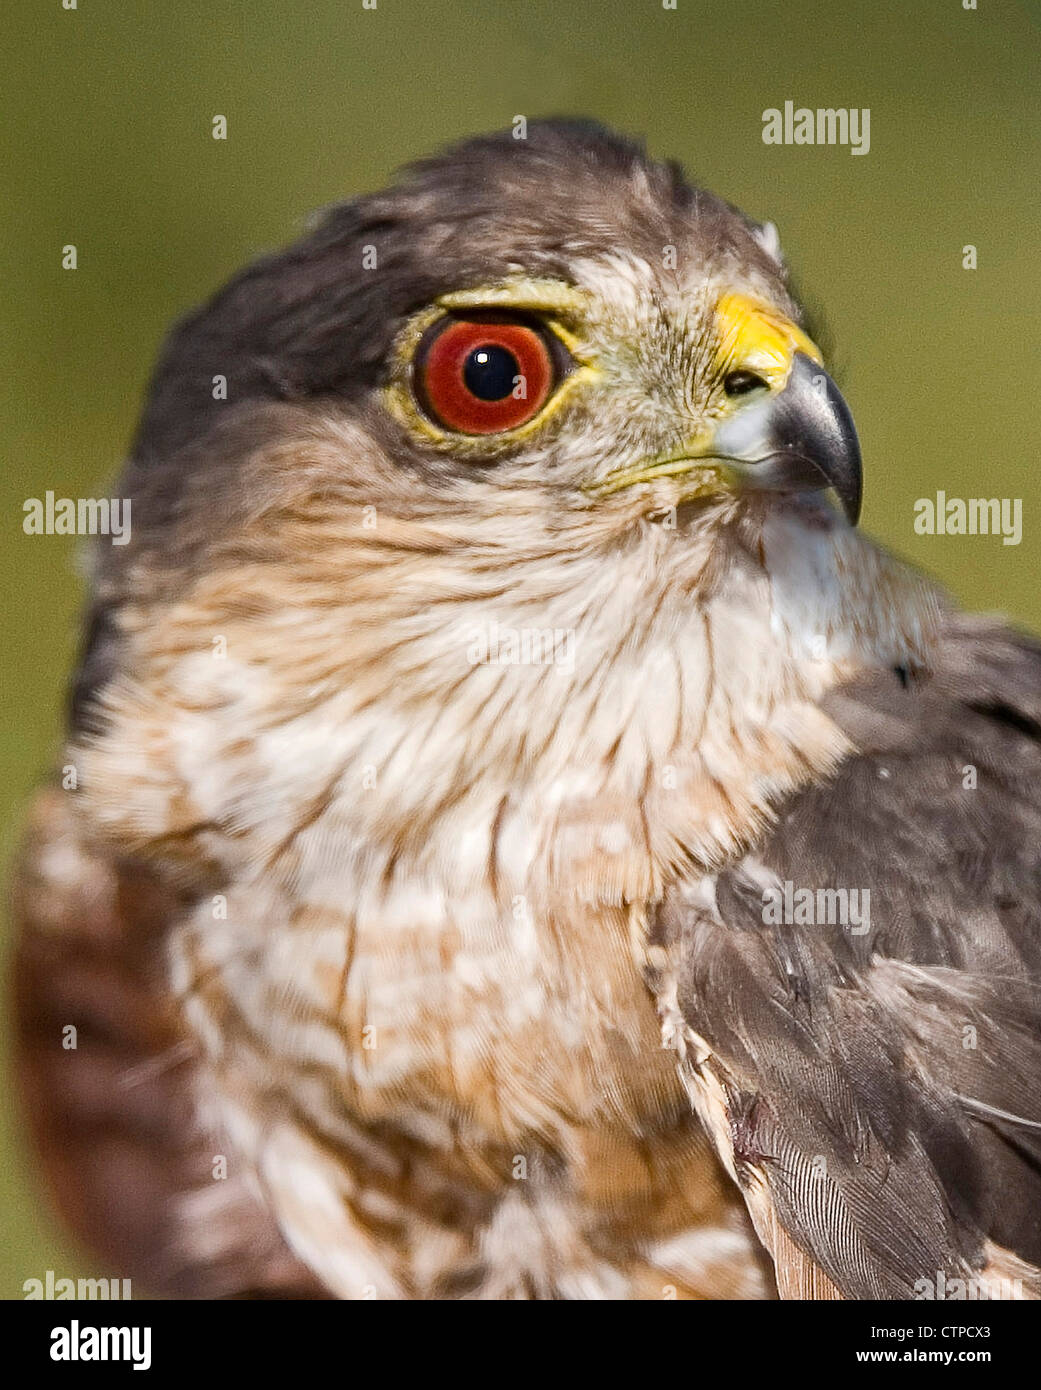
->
[119,121,860,564]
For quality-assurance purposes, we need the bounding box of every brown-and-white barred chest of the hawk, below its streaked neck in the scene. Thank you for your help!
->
[164,872,762,1297]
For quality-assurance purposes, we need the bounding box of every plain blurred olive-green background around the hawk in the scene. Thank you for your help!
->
[0,0,1041,1297]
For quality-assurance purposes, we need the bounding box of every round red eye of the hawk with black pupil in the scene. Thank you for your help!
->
[416,318,556,434]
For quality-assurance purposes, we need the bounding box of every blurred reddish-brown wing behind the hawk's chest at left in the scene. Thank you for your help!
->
[14,788,321,1297]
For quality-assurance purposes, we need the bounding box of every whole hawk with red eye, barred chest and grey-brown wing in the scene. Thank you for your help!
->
[15,121,1041,1298]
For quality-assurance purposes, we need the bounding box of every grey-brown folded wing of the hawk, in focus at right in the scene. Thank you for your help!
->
[657,619,1041,1298]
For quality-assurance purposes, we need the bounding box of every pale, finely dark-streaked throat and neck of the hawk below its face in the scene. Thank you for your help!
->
[71,492,938,922]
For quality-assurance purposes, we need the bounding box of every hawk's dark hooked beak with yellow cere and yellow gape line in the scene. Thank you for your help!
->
[599,293,862,525]
